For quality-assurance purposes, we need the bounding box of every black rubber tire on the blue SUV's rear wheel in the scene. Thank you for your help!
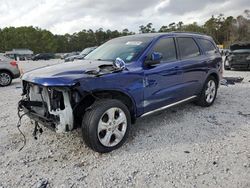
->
[196,76,218,107]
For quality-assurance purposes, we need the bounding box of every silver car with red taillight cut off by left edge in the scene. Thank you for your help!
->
[0,55,20,87]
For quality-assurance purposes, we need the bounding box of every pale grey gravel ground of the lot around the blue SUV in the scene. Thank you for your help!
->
[0,60,250,188]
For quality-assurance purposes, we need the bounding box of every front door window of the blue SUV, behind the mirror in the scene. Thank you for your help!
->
[150,38,177,61]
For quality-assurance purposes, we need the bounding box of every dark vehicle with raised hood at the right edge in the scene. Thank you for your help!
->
[224,43,250,70]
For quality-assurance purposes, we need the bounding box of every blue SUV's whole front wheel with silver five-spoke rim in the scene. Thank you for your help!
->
[82,99,131,153]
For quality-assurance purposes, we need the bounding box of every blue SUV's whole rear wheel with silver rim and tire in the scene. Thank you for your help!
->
[196,76,218,107]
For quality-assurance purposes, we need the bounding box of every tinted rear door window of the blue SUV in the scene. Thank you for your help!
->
[177,37,200,59]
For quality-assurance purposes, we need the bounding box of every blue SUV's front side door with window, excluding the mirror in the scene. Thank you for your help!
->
[144,37,181,113]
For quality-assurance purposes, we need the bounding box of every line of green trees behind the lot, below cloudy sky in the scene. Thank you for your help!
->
[0,10,250,53]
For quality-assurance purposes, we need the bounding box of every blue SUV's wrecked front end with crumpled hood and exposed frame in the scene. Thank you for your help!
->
[18,58,125,132]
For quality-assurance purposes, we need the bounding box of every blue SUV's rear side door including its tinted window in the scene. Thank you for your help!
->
[176,37,208,99]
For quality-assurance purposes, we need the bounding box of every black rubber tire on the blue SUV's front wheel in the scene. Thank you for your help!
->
[82,99,131,153]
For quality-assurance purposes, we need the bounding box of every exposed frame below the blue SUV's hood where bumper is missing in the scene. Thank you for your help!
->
[18,81,74,132]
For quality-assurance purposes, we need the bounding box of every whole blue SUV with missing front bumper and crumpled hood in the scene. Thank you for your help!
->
[19,32,222,153]
